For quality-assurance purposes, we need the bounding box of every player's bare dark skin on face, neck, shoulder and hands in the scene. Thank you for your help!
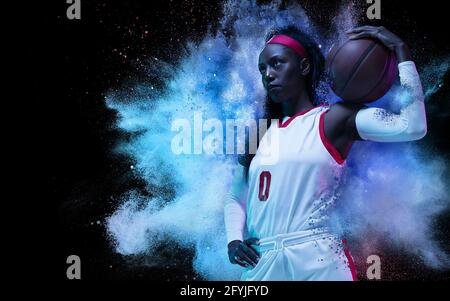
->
[228,26,411,267]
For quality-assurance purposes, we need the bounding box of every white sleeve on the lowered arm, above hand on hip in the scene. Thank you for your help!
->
[224,164,248,242]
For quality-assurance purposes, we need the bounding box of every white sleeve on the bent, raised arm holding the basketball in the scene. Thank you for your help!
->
[355,61,427,142]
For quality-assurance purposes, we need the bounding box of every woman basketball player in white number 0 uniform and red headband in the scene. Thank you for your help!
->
[224,26,427,280]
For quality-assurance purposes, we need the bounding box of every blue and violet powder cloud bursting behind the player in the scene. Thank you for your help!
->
[106,0,448,280]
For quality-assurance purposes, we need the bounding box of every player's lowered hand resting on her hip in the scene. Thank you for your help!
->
[228,237,260,267]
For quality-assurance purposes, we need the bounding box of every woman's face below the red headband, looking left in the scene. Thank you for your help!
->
[258,44,309,103]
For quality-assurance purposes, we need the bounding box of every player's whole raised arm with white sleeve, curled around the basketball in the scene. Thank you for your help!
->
[329,26,427,142]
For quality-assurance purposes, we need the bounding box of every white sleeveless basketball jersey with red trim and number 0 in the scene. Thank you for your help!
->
[247,106,345,238]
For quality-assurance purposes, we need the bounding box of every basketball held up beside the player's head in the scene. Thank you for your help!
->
[326,39,398,103]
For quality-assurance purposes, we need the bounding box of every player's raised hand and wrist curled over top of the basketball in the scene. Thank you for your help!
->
[346,26,411,63]
